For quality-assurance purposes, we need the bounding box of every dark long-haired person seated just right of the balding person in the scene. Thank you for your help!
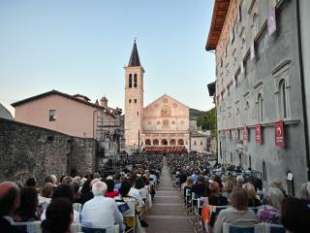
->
[14,187,39,222]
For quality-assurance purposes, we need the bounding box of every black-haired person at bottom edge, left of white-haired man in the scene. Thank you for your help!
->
[41,198,73,233]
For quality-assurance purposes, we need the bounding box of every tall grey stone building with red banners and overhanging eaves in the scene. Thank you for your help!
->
[206,0,308,192]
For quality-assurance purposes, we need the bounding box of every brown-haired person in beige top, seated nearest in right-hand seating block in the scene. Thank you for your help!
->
[213,188,258,233]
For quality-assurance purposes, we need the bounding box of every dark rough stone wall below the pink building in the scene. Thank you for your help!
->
[0,119,96,183]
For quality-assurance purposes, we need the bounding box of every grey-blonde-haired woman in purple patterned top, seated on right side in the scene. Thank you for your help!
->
[257,187,284,224]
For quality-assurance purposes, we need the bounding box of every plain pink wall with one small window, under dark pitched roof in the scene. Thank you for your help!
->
[15,95,96,138]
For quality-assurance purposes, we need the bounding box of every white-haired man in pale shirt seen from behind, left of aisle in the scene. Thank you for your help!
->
[81,181,123,228]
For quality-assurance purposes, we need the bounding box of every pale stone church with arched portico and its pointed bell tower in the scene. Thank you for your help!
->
[124,42,191,153]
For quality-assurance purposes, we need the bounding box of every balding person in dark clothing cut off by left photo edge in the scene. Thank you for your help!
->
[0,182,20,233]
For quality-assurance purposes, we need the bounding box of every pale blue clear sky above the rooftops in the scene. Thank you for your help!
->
[0,0,215,115]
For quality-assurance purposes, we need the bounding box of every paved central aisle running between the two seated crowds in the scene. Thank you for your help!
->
[146,159,194,233]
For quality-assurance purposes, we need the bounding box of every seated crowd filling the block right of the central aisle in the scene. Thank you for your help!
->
[169,156,310,233]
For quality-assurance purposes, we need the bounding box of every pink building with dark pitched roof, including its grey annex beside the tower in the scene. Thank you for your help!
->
[12,90,123,156]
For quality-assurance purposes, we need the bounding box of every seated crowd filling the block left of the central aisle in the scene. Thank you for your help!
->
[0,155,162,233]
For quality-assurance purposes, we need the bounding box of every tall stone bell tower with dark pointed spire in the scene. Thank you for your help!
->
[125,40,144,151]
